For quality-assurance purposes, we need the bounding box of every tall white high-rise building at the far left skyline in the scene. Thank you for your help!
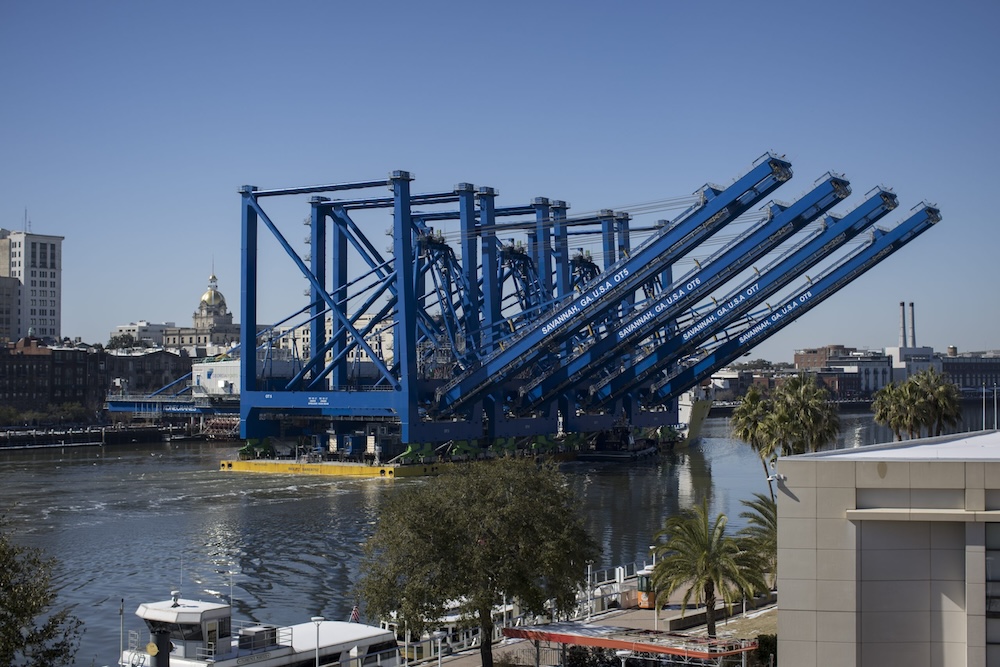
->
[0,229,63,340]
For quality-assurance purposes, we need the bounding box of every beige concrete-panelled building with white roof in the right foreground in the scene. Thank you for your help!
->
[777,431,1000,667]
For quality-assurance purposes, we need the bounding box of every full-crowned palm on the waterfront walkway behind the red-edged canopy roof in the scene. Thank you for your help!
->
[653,501,766,637]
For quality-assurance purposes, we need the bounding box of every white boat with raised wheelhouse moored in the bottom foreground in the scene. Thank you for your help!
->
[119,591,400,667]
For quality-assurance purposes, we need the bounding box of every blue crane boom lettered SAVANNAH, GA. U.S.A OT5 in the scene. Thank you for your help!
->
[436,154,791,414]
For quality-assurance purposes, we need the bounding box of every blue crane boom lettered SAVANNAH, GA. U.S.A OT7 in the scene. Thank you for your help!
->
[580,188,897,407]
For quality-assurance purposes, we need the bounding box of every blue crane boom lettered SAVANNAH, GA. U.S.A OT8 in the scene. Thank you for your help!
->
[649,204,941,404]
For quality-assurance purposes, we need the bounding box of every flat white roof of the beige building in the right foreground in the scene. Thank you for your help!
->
[789,431,1000,461]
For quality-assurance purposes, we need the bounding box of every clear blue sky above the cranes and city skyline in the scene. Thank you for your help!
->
[0,0,1000,361]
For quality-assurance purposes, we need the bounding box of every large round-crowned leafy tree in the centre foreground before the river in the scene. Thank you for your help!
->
[357,458,599,667]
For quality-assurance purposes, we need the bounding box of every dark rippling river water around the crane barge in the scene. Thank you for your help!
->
[0,410,981,667]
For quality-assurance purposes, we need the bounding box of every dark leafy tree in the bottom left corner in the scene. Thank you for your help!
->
[0,517,83,667]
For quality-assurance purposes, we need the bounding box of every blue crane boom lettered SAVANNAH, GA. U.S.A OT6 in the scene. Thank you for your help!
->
[518,175,851,411]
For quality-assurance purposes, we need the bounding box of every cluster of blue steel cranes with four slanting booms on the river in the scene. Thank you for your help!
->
[240,153,940,458]
